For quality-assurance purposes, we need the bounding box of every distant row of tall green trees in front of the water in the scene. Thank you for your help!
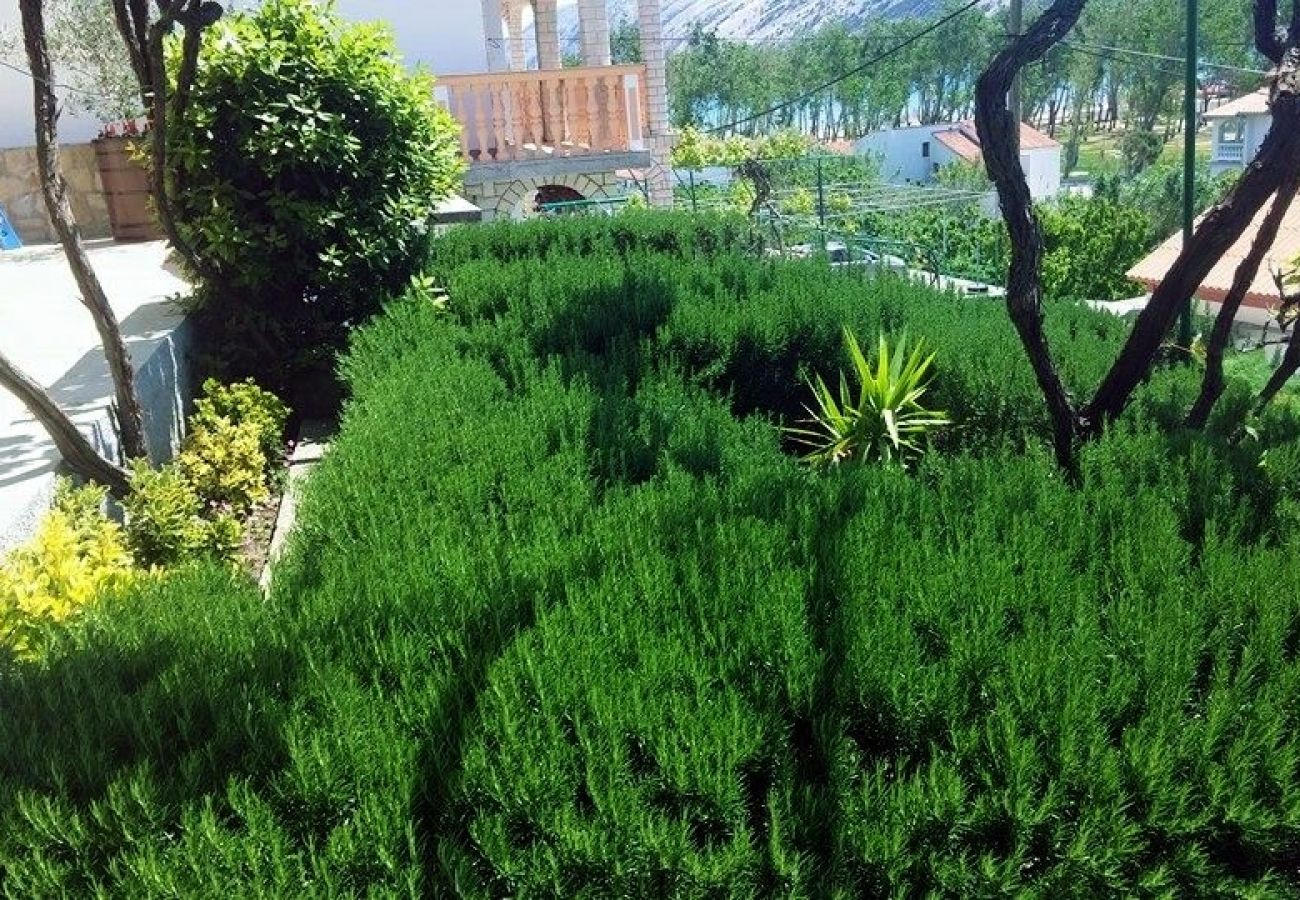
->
[644,0,1268,150]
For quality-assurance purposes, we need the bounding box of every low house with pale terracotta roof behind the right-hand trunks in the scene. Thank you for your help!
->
[1128,189,1300,325]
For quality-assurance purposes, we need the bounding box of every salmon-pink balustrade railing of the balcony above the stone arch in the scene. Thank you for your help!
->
[434,65,646,164]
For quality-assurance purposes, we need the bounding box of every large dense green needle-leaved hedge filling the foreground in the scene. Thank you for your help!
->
[0,210,1300,896]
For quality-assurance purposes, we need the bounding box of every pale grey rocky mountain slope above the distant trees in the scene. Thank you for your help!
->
[560,0,987,42]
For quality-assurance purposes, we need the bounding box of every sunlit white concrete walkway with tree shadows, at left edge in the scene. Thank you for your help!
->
[0,241,191,550]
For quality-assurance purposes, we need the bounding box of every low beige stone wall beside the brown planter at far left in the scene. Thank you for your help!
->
[0,144,111,243]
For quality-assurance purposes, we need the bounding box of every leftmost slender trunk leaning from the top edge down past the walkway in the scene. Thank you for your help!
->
[18,0,148,458]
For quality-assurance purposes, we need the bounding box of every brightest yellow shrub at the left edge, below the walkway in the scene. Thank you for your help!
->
[0,483,134,657]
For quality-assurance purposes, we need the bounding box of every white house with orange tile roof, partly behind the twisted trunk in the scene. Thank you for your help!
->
[857,122,1061,200]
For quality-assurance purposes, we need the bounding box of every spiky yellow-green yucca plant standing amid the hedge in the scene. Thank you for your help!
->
[787,328,952,466]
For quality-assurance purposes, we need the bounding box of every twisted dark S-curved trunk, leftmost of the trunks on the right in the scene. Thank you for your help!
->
[975,0,1086,470]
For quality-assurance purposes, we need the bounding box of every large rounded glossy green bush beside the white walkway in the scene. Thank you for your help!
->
[168,0,460,373]
